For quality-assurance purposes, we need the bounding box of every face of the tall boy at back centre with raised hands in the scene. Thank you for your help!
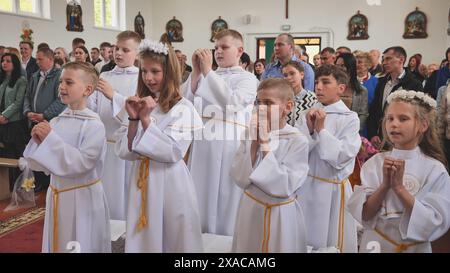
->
[214,36,244,68]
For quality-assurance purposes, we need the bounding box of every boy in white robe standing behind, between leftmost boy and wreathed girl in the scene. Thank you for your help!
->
[89,31,141,221]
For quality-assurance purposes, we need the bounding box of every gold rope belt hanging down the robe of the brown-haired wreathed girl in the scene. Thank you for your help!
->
[136,157,150,232]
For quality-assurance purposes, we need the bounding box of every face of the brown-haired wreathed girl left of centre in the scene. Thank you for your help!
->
[141,58,164,94]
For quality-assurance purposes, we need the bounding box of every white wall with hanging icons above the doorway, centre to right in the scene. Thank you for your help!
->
[152,0,450,63]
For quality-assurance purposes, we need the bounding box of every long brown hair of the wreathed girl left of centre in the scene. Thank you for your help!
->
[137,42,182,113]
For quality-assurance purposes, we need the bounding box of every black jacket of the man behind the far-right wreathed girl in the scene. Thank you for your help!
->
[367,70,423,140]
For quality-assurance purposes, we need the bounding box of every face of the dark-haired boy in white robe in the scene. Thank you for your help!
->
[316,75,347,105]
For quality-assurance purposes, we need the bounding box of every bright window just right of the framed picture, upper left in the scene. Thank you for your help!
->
[94,0,126,30]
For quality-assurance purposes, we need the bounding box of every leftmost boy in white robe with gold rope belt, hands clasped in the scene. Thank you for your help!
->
[24,62,111,252]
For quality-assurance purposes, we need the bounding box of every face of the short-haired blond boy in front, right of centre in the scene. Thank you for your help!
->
[256,88,293,129]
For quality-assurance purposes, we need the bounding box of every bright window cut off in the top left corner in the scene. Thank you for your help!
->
[0,0,50,19]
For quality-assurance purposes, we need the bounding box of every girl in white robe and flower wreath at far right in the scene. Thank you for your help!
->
[348,90,450,253]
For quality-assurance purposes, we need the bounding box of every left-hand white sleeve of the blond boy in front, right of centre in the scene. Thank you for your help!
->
[230,140,253,190]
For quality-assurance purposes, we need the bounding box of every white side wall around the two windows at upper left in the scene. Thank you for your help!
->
[0,0,152,54]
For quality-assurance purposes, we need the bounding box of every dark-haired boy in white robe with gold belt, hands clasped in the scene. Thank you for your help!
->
[296,65,361,252]
